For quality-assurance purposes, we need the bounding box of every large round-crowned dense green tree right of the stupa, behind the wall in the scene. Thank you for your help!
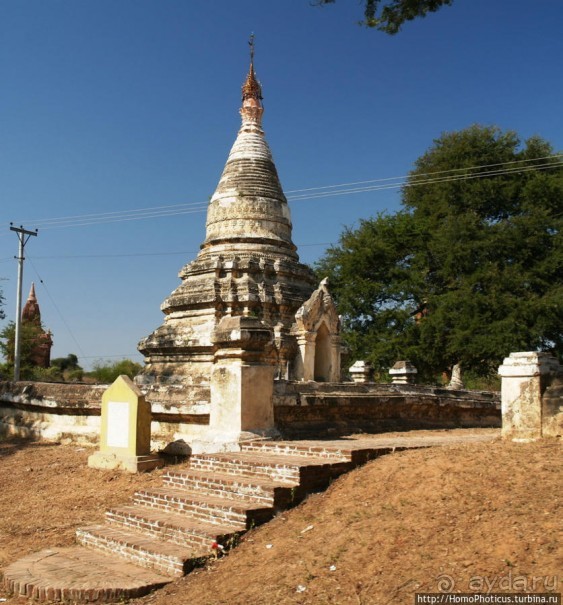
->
[317,126,563,378]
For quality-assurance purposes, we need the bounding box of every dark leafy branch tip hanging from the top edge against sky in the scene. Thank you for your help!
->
[316,0,453,35]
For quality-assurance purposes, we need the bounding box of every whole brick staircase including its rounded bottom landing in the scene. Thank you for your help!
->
[4,441,404,602]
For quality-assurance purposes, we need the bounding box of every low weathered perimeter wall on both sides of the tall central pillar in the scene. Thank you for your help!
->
[0,381,501,449]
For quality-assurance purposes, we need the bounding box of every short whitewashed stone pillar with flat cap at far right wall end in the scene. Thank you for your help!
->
[498,352,561,441]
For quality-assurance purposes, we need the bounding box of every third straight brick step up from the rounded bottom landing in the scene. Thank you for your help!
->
[133,487,274,531]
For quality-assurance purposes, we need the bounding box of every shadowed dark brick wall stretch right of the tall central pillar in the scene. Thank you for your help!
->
[274,382,501,438]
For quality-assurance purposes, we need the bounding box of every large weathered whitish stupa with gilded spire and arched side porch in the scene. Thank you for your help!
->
[136,49,340,403]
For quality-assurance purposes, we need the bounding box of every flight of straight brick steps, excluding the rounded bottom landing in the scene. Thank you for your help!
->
[77,442,388,577]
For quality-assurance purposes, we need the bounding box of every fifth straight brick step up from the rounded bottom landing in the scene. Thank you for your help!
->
[189,452,352,489]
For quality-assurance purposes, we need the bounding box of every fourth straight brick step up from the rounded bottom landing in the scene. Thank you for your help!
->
[163,468,299,508]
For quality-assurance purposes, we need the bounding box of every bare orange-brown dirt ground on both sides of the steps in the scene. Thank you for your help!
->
[0,434,563,605]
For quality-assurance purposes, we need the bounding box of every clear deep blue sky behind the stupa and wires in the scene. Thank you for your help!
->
[0,0,563,367]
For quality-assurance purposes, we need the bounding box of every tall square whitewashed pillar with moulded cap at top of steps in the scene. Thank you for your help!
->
[209,316,275,449]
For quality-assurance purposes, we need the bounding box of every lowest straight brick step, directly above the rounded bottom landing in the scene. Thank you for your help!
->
[76,525,196,577]
